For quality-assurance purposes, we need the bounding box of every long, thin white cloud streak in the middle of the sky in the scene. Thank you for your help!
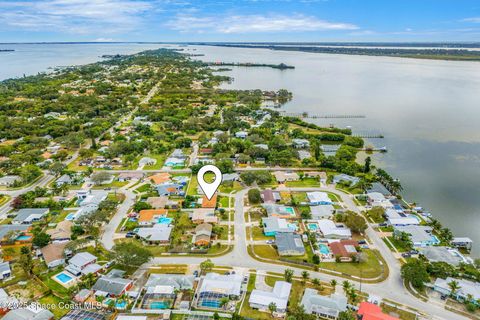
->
[167,14,358,34]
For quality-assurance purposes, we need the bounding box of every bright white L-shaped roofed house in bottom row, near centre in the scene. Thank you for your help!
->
[248,281,292,314]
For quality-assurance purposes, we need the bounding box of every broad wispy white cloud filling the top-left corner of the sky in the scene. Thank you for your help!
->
[0,0,152,34]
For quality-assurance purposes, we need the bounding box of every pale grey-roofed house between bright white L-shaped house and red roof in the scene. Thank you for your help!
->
[300,288,348,319]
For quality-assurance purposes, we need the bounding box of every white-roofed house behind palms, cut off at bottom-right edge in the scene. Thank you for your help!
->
[433,277,480,305]
